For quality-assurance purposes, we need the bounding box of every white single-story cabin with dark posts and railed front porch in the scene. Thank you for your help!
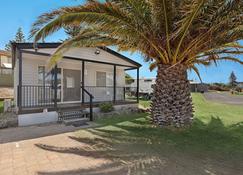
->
[12,43,141,126]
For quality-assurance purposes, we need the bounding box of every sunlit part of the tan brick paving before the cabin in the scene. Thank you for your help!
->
[0,131,109,175]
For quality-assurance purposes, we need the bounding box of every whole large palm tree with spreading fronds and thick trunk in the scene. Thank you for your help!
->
[31,0,243,127]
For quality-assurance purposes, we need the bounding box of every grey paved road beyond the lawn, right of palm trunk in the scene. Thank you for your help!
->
[204,92,243,105]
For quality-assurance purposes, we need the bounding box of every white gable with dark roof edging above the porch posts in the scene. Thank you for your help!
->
[13,43,142,69]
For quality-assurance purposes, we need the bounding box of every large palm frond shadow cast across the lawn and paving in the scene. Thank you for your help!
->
[36,117,243,175]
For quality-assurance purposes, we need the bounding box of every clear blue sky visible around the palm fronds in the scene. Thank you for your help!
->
[0,0,243,83]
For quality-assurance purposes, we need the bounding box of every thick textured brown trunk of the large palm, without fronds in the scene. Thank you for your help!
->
[151,64,193,127]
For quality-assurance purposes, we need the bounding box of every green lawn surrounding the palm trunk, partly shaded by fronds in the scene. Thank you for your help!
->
[72,94,243,175]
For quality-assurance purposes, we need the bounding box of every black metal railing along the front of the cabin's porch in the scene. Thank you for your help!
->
[18,85,137,108]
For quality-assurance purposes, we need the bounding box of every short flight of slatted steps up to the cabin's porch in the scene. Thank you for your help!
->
[58,110,89,121]
